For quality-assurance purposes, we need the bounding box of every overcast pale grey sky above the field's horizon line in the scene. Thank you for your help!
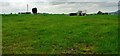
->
[0,0,119,14]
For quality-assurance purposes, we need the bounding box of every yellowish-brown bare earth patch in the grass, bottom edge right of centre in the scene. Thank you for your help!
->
[62,43,94,54]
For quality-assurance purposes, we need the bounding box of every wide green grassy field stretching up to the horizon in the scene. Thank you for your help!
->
[2,14,118,54]
